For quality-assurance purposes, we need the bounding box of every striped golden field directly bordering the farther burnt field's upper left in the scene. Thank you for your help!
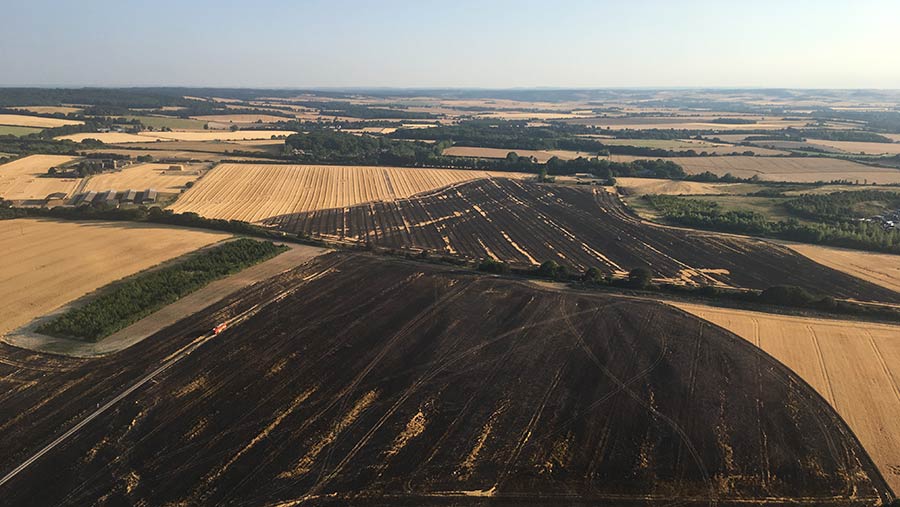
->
[170,164,533,222]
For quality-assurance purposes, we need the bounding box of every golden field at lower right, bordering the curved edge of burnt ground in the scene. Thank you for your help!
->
[671,303,900,490]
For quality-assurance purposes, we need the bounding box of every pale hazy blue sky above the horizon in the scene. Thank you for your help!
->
[0,0,900,88]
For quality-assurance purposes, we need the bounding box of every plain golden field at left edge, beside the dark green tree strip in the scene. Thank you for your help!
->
[0,219,230,335]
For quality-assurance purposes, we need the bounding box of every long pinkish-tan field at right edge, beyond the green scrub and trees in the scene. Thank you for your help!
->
[666,157,900,184]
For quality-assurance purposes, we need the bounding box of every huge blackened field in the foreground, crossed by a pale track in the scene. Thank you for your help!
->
[0,254,893,506]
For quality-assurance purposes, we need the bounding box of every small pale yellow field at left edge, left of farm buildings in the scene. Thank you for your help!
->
[0,155,81,200]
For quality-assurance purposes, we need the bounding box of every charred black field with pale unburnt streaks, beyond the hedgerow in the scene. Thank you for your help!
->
[267,179,900,302]
